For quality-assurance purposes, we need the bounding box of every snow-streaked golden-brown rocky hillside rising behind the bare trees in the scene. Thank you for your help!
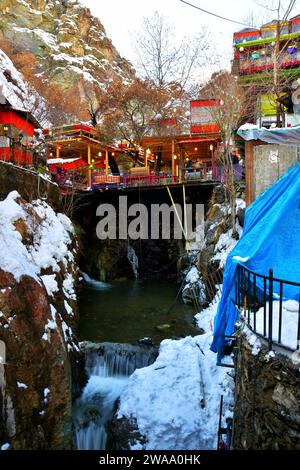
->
[0,0,134,121]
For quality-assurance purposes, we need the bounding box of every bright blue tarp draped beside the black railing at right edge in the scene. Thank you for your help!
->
[211,163,300,361]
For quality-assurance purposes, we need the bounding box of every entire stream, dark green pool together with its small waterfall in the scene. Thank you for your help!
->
[73,275,199,450]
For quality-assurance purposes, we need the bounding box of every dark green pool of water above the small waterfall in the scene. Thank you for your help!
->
[79,280,199,345]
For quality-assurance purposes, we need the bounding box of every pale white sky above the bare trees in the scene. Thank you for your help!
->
[80,0,300,66]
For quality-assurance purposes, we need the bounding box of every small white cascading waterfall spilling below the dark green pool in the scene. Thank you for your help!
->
[73,343,157,450]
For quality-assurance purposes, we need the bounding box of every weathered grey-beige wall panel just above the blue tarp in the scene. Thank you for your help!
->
[253,145,300,199]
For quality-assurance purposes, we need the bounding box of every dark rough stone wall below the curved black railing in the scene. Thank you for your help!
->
[233,333,300,450]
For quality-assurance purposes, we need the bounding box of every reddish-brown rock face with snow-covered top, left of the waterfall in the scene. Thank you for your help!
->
[0,191,80,449]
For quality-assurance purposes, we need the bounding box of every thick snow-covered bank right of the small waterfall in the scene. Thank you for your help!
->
[118,294,233,450]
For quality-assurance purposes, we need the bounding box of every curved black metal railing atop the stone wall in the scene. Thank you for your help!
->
[236,265,300,351]
